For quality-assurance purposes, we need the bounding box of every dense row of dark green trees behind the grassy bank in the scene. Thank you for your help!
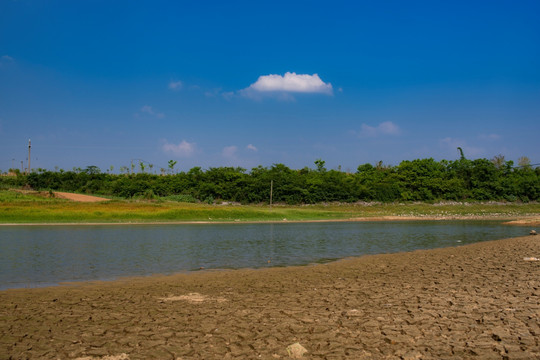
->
[0,156,540,204]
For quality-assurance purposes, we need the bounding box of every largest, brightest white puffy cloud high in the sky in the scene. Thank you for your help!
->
[241,72,333,96]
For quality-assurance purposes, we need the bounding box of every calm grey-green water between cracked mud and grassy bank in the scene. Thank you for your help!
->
[0,221,527,289]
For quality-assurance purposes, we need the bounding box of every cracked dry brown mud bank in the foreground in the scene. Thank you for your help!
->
[0,236,540,359]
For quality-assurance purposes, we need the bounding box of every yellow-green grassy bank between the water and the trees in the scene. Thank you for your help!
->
[0,190,540,223]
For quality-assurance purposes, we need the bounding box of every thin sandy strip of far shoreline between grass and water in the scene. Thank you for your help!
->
[0,215,540,227]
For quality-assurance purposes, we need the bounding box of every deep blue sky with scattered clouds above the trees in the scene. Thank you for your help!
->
[0,0,540,171]
